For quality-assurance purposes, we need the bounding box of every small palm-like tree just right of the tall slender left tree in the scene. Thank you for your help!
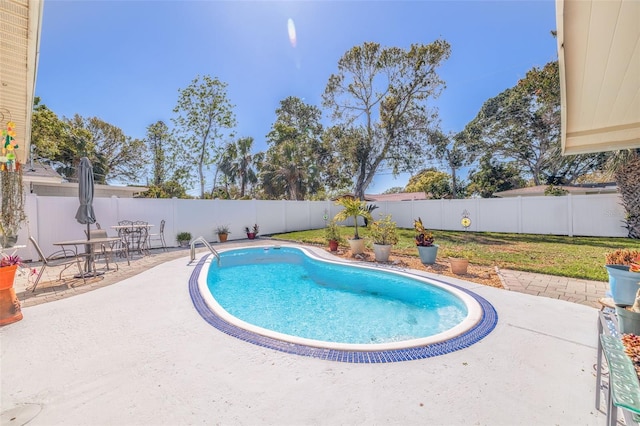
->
[220,137,262,198]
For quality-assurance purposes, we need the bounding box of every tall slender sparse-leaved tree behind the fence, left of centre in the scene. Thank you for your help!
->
[172,75,236,198]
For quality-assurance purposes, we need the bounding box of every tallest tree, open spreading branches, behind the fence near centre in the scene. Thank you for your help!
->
[323,40,450,198]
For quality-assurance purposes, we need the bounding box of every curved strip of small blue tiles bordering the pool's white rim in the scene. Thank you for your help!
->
[189,254,498,363]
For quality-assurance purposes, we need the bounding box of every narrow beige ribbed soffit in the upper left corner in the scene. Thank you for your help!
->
[0,0,43,163]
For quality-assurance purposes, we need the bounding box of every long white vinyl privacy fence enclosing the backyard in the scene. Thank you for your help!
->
[12,194,627,259]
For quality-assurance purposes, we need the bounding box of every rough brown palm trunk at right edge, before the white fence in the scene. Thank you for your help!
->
[607,148,640,239]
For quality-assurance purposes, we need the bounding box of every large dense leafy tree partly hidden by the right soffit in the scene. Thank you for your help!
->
[465,61,604,185]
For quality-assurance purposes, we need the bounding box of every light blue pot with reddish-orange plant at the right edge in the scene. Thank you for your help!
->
[605,249,640,306]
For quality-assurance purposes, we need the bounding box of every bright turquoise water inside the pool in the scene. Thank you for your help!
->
[207,247,467,344]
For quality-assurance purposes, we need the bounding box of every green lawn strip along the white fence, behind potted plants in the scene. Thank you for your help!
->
[272,227,640,281]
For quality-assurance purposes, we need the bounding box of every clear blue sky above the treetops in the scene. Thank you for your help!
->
[36,0,557,193]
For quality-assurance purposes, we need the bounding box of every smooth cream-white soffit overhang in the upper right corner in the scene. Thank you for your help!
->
[556,0,640,154]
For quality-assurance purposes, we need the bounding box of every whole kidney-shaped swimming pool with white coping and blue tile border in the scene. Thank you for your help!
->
[190,246,497,362]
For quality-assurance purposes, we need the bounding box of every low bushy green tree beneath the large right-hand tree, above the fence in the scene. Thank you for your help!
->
[467,154,526,198]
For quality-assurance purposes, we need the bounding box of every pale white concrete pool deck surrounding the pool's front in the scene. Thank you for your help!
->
[0,241,606,425]
